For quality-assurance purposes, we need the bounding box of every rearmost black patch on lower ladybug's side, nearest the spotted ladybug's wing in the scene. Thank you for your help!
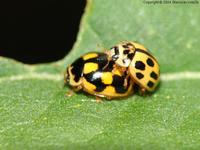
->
[111,75,127,93]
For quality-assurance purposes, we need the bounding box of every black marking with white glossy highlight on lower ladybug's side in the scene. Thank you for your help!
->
[84,71,107,92]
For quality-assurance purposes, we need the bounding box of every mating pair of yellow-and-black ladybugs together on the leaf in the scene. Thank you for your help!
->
[65,42,160,99]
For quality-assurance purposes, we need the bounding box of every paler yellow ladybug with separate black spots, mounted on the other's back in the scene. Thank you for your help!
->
[105,41,160,93]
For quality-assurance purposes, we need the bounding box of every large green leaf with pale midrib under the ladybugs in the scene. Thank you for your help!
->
[0,0,200,150]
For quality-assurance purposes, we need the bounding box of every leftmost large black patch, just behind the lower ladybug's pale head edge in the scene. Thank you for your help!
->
[71,57,84,82]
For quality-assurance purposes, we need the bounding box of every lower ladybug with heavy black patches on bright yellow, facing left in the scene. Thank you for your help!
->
[64,52,134,99]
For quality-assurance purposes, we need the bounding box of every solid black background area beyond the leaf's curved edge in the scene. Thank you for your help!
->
[0,0,86,64]
